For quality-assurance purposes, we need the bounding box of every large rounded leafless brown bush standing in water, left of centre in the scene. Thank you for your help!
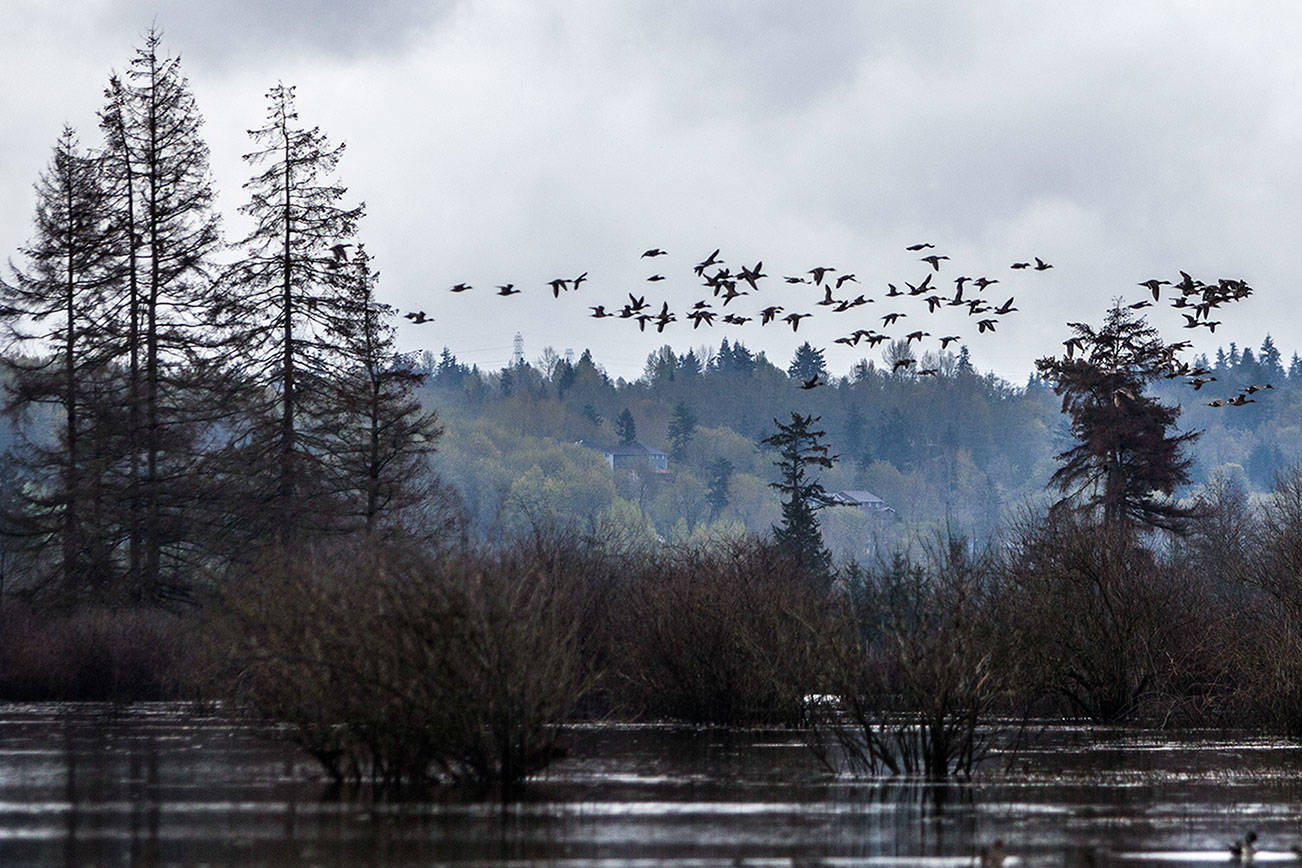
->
[205,545,590,786]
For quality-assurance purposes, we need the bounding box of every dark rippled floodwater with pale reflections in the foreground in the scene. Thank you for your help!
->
[0,704,1302,868]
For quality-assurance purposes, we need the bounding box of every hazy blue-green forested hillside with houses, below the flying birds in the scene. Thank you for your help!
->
[421,336,1302,557]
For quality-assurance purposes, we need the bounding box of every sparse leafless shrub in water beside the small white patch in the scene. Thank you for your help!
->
[811,537,1014,780]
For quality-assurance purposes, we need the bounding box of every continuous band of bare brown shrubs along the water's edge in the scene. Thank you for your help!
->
[0,474,1302,789]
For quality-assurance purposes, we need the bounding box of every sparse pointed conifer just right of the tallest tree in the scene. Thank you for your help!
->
[217,85,363,541]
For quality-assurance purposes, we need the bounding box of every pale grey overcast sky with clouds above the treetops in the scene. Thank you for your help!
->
[0,0,1302,381]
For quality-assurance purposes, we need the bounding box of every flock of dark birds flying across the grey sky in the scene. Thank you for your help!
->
[405,242,1272,407]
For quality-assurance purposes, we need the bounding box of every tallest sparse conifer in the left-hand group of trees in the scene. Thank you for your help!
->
[100,29,220,593]
